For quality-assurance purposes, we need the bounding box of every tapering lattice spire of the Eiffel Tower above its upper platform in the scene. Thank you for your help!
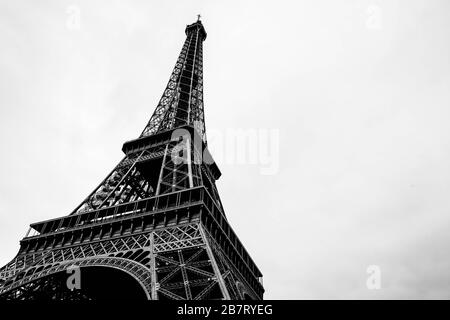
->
[140,18,206,143]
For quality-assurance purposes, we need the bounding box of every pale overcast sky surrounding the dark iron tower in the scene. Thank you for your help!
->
[0,0,450,299]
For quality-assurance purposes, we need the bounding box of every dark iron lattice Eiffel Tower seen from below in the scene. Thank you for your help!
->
[0,17,264,300]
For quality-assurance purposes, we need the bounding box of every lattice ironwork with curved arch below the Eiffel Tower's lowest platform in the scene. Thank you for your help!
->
[0,223,256,300]
